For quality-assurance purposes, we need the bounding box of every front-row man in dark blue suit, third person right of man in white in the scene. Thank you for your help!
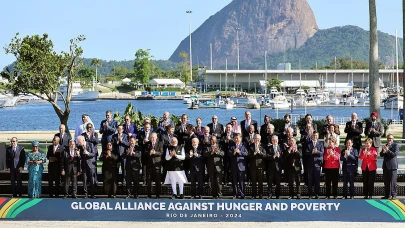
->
[228,133,248,199]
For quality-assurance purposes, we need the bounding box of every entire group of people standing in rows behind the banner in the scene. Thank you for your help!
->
[7,111,399,199]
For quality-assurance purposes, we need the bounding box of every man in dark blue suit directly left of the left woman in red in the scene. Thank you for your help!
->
[305,131,324,199]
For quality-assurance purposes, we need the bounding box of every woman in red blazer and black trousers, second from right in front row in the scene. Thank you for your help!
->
[359,138,377,199]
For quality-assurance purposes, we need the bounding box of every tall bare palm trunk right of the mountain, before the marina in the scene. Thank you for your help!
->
[369,0,380,116]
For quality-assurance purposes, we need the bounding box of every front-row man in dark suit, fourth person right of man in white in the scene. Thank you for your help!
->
[248,134,266,199]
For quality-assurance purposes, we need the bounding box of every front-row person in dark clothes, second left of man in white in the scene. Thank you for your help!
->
[121,138,142,199]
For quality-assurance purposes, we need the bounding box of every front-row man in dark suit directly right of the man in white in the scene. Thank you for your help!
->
[185,138,205,199]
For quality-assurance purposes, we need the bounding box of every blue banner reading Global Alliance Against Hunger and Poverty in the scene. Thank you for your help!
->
[0,198,405,222]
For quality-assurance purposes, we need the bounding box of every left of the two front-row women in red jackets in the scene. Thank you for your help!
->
[323,137,340,199]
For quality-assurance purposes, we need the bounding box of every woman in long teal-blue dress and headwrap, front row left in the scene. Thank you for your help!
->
[26,140,46,198]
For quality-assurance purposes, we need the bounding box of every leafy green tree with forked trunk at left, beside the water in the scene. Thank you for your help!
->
[1,33,85,130]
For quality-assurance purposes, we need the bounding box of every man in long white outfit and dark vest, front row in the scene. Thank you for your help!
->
[164,137,187,199]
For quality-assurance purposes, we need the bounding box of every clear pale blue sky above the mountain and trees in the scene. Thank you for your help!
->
[0,0,402,69]
